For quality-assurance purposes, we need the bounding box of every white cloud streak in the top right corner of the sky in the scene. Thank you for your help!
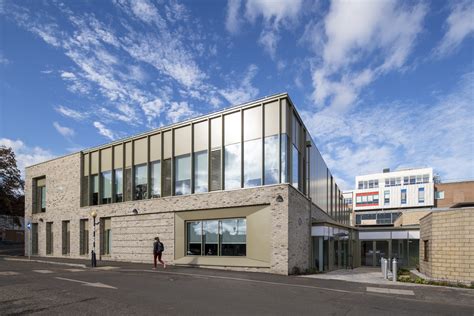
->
[435,0,474,57]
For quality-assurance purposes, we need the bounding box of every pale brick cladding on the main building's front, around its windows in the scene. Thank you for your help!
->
[25,153,310,274]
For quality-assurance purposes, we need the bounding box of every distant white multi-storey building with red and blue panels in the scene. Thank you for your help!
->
[352,168,434,226]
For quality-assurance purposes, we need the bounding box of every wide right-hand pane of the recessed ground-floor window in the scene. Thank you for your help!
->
[221,218,247,256]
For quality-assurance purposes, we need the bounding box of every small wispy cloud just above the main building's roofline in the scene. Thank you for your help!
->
[219,64,259,104]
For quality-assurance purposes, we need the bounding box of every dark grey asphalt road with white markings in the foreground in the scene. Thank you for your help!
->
[0,258,474,315]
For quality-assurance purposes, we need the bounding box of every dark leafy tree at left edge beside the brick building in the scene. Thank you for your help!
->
[0,145,25,216]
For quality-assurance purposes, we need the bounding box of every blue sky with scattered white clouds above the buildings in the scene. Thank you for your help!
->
[0,0,474,189]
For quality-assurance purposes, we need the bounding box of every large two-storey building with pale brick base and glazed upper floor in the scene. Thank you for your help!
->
[25,94,352,274]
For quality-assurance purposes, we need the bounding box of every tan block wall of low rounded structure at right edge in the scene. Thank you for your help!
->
[420,208,474,283]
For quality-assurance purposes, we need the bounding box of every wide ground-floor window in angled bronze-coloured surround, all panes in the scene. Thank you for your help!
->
[186,218,247,256]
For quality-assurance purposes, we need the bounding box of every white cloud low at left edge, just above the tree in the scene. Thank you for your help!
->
[0,138,54,178]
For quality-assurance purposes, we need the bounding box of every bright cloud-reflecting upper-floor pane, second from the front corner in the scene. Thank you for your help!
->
[244,139,262,188]
